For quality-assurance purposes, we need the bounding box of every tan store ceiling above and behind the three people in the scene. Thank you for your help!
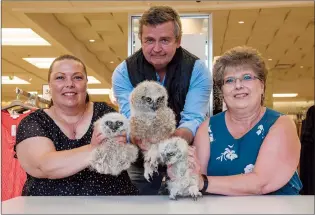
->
[2,1,314,109]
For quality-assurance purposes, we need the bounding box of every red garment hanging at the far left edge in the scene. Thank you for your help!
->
[1,110,30,201]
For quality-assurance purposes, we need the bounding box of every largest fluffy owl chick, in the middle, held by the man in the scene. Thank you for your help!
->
[130,81,176,180]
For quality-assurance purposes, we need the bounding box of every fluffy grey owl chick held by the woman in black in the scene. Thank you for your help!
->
[90,113,138,176]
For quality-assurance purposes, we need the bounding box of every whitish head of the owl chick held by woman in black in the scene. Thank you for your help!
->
[95,113,129,138]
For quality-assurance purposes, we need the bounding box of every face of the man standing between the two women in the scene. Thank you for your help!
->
[141,21,180,70]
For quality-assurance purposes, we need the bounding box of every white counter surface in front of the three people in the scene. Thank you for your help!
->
[2,196,314,214]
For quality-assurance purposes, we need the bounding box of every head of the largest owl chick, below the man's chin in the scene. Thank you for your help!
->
[130,81,168,112]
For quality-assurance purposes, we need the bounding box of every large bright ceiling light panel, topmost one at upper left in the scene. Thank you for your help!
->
[2,28,51,46]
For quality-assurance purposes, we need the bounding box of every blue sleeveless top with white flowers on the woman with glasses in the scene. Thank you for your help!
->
[207,108,302,195]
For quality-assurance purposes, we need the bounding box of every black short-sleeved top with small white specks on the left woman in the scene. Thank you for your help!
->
[16,102,138,196]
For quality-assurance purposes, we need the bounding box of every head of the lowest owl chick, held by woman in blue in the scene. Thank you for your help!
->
[159,138,188,165]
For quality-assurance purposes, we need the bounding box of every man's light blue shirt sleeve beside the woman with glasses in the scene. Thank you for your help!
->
[179,60,213,136]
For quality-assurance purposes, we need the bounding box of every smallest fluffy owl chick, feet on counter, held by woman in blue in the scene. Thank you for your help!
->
[158,137,202,200]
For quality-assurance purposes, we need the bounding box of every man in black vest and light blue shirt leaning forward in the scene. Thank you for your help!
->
[112,6,212,195]
